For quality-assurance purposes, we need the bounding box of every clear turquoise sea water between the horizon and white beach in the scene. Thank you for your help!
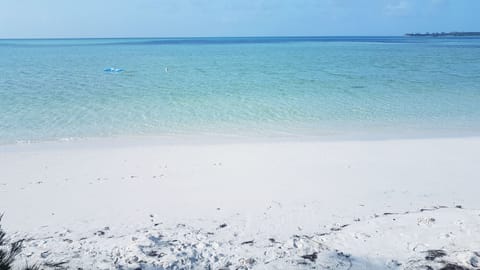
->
[0,37,480,144]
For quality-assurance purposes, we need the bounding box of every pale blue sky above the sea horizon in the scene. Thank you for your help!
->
[0,0,480,38]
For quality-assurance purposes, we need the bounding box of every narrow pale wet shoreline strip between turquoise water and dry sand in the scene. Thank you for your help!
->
[0,131,480,152]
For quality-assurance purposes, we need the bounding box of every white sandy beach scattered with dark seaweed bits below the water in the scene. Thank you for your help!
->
[0,138,480,269]
